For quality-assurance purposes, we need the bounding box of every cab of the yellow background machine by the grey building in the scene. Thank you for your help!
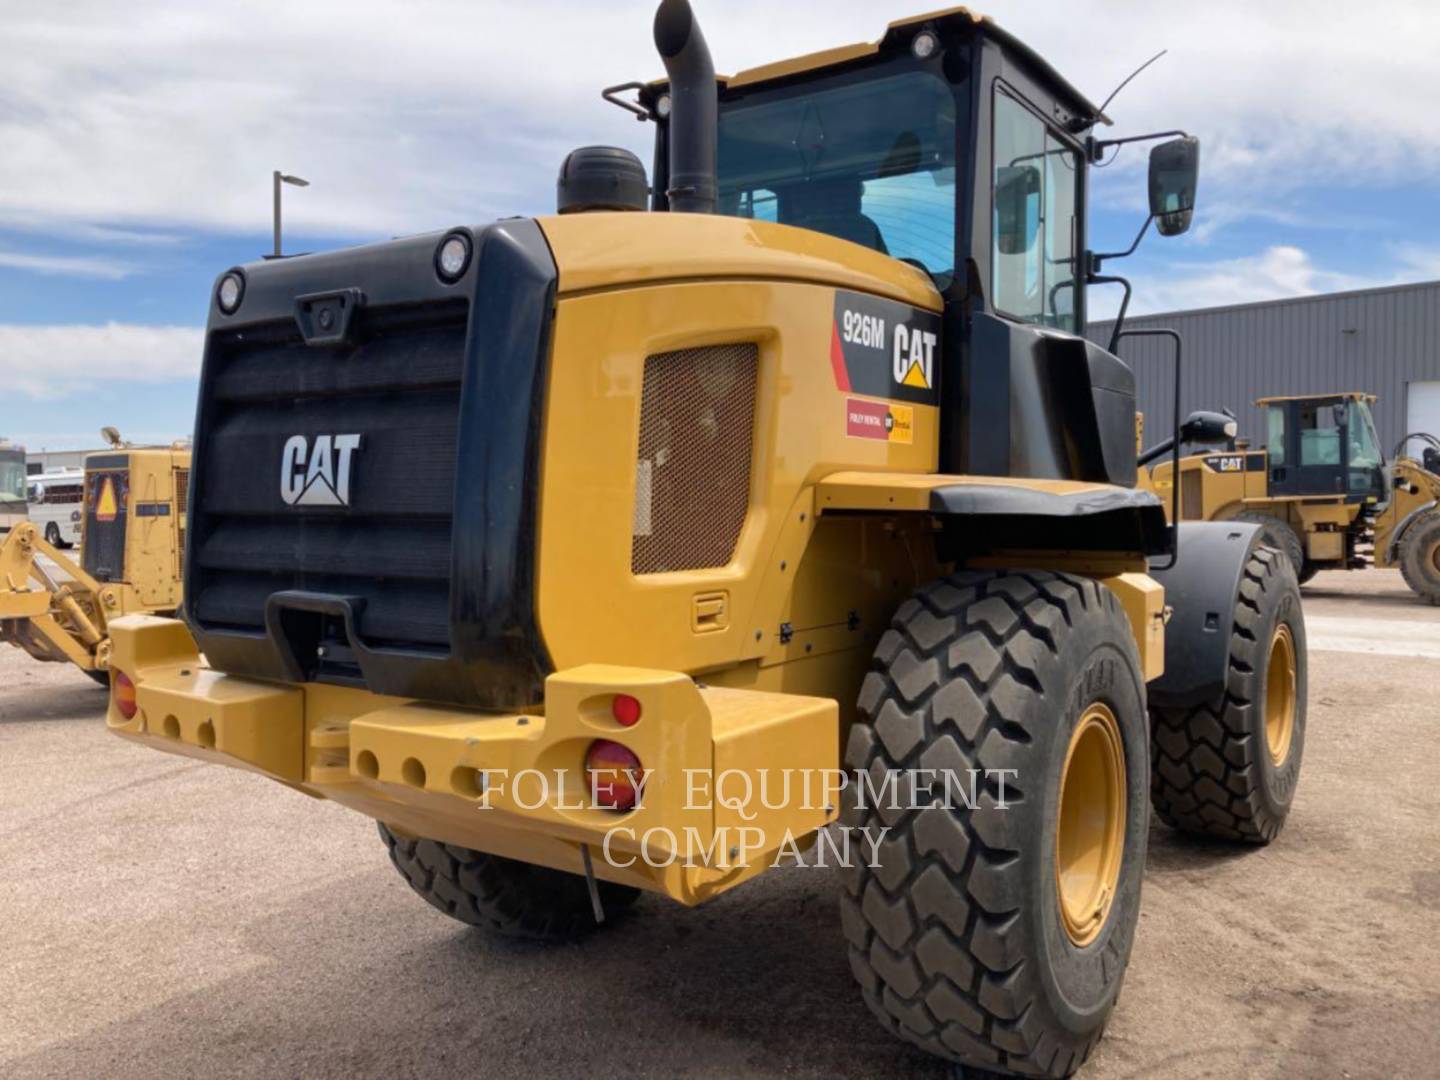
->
[1256,393,1390,503]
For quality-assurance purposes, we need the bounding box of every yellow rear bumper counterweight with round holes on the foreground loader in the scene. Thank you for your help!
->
[107,615,841,904]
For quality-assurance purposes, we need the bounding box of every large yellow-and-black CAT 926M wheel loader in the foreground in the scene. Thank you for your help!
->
[108,0,1306,1077]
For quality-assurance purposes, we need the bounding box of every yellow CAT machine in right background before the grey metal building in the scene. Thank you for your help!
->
[1142,393,1440,603]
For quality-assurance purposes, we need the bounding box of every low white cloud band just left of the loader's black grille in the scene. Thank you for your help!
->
[0,323,204,412]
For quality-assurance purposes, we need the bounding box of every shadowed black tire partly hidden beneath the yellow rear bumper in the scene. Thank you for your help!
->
[377,822,639,940]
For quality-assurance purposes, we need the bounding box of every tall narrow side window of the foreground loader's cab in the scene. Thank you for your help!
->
[991,86,1080,331]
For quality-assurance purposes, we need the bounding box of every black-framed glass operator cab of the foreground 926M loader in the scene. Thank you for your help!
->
[624,6,1198,487]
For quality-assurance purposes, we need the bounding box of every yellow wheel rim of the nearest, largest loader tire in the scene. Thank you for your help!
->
[1056,701,1126,948]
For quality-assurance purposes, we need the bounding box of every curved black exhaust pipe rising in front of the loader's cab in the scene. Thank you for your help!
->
[655,0,719,213]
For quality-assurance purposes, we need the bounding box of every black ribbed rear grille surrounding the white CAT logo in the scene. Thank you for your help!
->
[186,301,468,651]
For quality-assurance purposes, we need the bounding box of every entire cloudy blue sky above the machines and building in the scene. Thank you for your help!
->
[0,0,1440,448]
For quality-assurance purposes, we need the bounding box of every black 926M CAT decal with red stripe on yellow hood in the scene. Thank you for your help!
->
[829,289,940,406]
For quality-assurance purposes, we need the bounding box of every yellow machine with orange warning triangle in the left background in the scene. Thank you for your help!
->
[0,429,190,683]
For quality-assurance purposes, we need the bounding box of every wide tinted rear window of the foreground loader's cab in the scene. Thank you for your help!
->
[719,71,958,288]
